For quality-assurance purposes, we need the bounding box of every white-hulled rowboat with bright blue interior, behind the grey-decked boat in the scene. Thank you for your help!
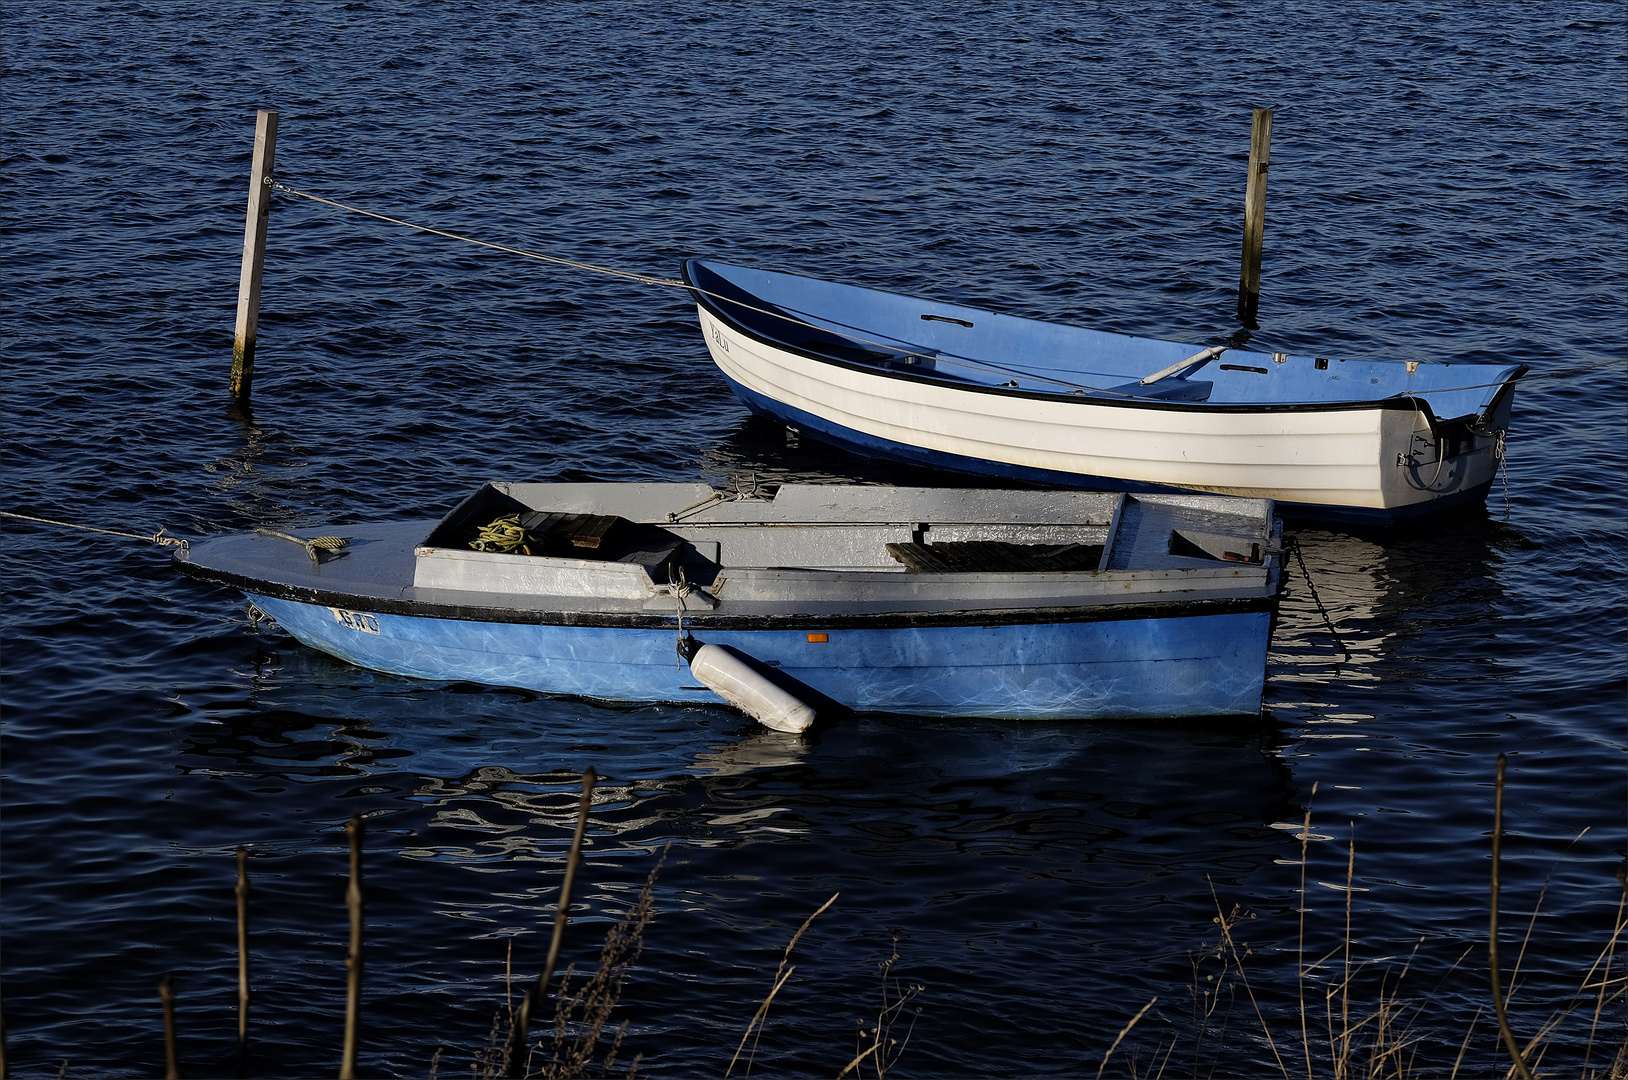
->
[684,259,1527,525]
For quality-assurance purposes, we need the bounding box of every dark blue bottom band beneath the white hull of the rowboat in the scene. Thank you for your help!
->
[723,375,1491,528]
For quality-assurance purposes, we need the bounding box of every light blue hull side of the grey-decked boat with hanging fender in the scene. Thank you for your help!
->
[251,593,1271,718]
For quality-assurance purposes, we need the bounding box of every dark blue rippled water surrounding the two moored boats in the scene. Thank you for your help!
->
[0,0,1628,1077]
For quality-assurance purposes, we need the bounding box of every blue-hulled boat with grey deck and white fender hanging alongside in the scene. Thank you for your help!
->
[176,484,1281,718]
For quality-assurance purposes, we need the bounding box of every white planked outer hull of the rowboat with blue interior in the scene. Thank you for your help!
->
[698,308,1511,520]
